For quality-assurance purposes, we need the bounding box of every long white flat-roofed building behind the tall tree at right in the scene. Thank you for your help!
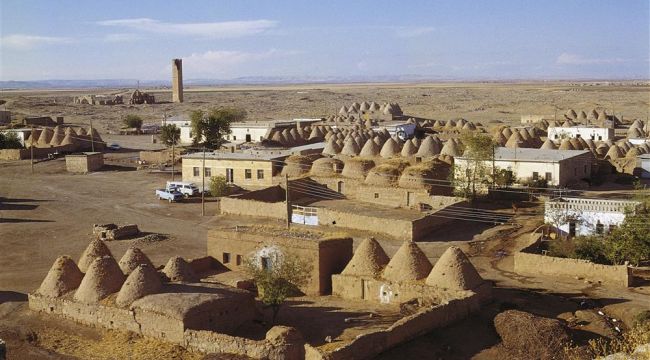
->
[454,147,594,186]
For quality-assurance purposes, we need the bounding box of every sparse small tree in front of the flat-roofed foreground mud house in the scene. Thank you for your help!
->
[245,247,312,323]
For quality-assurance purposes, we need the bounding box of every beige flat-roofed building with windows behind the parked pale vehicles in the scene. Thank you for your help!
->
[182,152,287,189]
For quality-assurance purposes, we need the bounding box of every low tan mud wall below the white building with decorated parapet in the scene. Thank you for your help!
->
[514,241,632,287]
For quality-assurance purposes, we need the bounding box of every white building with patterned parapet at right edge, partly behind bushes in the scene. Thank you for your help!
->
[544,197,640,236]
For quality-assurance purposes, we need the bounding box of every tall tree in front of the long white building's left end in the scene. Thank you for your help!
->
[451,131,496,200]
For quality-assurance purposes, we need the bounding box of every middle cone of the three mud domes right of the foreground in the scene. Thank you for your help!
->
[382,241,431,281]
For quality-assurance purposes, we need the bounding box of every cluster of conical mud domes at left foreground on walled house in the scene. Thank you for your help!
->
[36,239,198,307]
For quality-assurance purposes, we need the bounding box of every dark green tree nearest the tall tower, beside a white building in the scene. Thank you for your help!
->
[190,108,246,149]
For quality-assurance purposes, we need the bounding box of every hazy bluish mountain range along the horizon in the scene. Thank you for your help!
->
[0,75,647,90]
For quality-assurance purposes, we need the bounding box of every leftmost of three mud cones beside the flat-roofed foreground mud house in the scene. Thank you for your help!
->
[341,238,389,278]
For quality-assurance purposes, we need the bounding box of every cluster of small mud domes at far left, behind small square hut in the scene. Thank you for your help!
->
[25,125,103,151]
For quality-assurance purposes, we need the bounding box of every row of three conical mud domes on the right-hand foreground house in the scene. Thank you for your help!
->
[341,238,484,291]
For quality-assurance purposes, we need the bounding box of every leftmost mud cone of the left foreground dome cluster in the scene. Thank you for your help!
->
[36,256,84,297]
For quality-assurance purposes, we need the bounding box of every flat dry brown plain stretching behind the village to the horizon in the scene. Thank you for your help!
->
[0,82,650,131]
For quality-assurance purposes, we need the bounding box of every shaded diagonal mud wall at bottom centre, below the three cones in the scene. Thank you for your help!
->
[305,295,480,360]
